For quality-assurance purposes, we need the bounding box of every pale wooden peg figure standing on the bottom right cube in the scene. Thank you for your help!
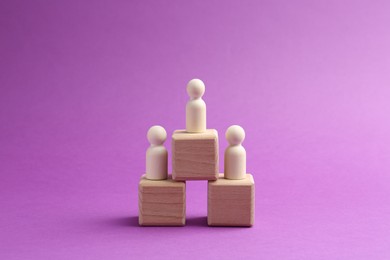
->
[224,125,246,180]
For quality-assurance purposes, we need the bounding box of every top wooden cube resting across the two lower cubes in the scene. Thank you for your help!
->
[172,129,219,180]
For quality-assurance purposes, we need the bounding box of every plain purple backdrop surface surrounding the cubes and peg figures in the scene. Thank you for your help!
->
[0,0,390,259]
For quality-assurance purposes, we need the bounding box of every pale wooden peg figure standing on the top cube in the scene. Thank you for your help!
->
[186,79,206,133]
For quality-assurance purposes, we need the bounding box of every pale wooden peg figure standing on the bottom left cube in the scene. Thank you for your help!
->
[146,125,168,180]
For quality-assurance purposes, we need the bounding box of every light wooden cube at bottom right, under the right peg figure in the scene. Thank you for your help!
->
[207,174,255,226]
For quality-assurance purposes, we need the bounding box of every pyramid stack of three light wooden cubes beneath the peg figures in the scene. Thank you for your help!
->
[138,80,255,226]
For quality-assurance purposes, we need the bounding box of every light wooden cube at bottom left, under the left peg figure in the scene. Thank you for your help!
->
[138,175,186,226]
